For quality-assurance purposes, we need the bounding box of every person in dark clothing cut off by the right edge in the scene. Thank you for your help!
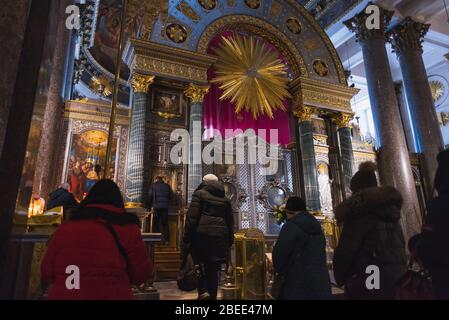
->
[417,149,449,300]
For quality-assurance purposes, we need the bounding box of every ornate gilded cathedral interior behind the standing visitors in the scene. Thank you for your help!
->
[0,0,449,299]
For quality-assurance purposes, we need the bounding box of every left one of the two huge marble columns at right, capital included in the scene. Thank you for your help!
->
[344,7,422,239]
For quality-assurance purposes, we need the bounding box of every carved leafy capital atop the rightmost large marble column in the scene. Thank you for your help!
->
[388,17,430,55]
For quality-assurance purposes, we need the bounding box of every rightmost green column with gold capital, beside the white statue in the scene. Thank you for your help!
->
[333,113,355,197]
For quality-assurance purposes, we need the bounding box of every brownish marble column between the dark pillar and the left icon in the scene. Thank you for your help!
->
[33,0,73,199]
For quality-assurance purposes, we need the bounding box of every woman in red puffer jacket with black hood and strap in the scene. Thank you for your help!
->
[41,180,153,300]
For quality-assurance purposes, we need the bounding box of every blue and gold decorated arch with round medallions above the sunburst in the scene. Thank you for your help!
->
[150,0,347,86]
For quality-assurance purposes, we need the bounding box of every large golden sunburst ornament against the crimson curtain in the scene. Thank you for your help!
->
[212,36,291,119]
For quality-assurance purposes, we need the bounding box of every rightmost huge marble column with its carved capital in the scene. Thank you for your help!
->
[389,17,444,199]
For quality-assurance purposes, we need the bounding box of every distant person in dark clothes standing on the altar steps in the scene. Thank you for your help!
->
[148,177,173,244]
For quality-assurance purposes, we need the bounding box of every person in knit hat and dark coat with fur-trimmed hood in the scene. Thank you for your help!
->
[333,162,407,299]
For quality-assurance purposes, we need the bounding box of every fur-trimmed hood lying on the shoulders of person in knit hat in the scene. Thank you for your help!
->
[335,186,403,224]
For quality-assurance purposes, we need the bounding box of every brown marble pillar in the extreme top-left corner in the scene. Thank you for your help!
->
[0,0,31,154]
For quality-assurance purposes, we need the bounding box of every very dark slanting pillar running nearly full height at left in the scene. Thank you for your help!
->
[0,0,51,299]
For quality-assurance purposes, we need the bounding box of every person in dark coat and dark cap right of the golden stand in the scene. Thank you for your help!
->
[273,197,332,300]
